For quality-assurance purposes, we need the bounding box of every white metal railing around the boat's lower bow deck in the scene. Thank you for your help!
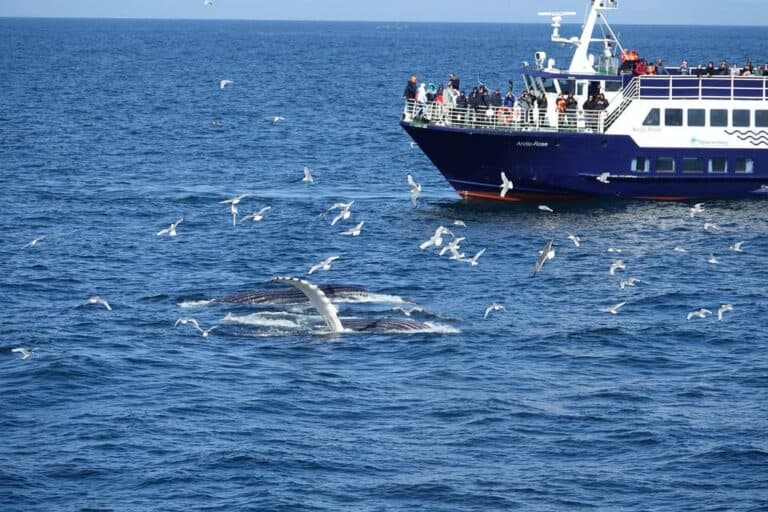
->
[403,101,605,133]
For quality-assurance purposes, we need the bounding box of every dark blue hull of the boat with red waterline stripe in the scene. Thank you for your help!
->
[401,121,768,201]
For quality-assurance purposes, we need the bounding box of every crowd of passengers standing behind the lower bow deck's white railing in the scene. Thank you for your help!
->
[403,73,608,127]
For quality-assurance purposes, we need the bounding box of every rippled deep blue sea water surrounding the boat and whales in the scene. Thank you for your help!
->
[0,19,768,511]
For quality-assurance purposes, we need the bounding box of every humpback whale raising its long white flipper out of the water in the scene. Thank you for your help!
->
[272,277,430,333]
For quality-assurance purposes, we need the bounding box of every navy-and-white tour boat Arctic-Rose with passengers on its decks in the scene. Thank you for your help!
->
[400,0,768,201]
